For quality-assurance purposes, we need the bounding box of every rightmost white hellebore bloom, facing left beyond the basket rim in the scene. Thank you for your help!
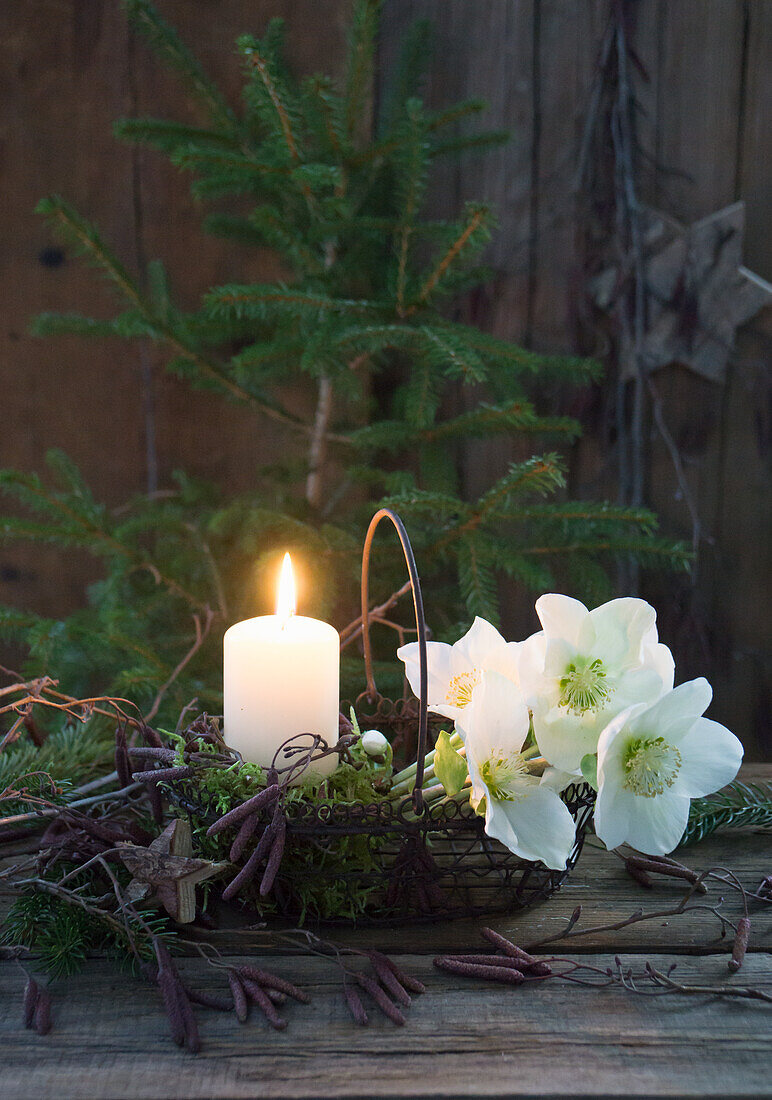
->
[595,678,742,856]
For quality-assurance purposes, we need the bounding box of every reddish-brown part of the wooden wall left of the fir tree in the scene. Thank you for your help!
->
[0,0,351,615]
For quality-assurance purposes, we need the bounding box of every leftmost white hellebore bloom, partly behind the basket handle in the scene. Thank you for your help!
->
[397,616,520,719]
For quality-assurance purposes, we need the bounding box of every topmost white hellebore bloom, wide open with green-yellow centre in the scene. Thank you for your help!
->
[519,593,673,772]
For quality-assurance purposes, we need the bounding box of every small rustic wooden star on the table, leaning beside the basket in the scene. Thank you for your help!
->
[120,820,230,924]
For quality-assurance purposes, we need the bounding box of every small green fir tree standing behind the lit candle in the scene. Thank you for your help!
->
[0,0,686,724]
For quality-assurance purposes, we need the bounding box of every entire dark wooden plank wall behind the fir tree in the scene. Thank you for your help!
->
[0,0,772,756]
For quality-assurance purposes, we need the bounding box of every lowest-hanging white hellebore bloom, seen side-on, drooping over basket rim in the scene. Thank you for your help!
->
[456,671,576,870]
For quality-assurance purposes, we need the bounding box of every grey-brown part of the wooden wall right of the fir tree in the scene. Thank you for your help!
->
[382,0,772,758]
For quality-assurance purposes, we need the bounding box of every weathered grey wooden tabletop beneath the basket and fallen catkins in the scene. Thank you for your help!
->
[0,766,772,1100]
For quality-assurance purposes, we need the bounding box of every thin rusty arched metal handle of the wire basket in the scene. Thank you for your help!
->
[362,508,428,814]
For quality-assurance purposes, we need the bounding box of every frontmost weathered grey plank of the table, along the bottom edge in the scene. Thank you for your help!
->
[0,955,772,1100]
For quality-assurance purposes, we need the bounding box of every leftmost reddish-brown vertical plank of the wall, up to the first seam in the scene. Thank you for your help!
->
[0,0,143,614]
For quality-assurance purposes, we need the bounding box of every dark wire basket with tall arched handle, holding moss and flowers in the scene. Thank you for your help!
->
[170,508,595,924]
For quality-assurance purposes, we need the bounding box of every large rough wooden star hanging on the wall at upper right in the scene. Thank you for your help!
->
[591,202,772,382]
